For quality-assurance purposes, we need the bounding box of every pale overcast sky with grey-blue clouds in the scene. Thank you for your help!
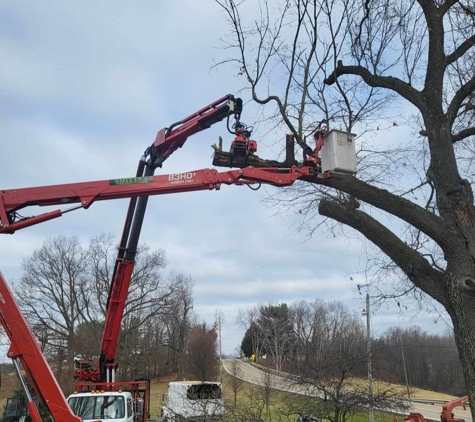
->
[0,0,454,353]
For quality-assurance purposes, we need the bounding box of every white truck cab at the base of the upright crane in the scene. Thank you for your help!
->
[68,391,136,422]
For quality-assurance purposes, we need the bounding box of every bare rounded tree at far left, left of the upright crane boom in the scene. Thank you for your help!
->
[15,236,90,381]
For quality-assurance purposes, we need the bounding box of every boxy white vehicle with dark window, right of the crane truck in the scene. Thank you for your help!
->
[162,381,224,422]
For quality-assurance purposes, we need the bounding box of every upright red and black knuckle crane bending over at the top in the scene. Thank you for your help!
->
[74,95,242,388]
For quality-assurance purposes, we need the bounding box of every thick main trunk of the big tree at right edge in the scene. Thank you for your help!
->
[425,120,475,410]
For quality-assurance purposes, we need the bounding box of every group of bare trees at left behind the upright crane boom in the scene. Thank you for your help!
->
[14,234,217,390]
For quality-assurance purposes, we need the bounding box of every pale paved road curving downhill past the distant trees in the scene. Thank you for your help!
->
[222,359,472,422]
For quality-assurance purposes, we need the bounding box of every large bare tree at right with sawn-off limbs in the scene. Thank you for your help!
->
[218,0,475,410]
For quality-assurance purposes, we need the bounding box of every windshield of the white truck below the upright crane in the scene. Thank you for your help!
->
[68,395,125,420]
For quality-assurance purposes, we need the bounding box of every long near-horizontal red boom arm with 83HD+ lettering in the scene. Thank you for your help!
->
[0,166,314,233]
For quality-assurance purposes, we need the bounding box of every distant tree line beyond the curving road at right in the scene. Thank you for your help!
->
[240,300,466,400]
